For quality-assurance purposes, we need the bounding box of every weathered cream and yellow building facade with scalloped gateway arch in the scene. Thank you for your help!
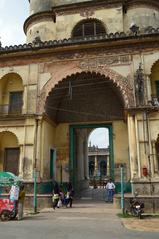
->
[0,0,159,194]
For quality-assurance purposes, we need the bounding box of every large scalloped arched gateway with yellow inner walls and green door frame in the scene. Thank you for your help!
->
[39,67,133,193]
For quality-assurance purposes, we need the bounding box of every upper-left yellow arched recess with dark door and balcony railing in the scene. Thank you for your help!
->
[0,73,24,115]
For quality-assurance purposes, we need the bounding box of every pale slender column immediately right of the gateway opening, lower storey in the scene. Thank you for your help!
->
[128,115,139,179]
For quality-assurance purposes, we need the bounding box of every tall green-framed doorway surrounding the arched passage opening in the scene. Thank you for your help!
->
[69,124,114,191]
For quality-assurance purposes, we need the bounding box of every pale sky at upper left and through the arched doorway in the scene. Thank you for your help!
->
[0,0,109,148]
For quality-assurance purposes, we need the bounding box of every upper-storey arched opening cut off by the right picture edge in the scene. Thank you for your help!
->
[150,61,159,104]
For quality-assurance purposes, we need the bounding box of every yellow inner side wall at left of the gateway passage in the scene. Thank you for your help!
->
[41,120,69,181]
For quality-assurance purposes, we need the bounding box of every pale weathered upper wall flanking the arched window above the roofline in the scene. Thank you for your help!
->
[27,7,123,42]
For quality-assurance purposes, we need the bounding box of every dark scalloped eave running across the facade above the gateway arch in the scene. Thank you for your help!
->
[0,28,159,55]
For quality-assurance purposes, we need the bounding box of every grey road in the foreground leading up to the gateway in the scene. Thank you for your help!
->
[0,202,159,239]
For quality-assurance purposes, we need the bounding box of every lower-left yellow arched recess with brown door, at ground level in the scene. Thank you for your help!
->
[0,131,20,175]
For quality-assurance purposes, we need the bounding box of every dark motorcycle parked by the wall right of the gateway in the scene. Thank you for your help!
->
[130,198,144,219]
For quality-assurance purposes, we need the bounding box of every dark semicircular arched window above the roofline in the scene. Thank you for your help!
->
[72,19,106,38]
